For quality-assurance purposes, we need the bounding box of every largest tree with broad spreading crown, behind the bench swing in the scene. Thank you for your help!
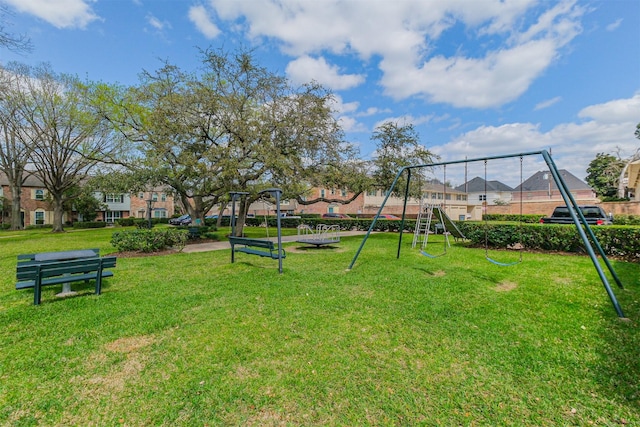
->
[95,50,350,236]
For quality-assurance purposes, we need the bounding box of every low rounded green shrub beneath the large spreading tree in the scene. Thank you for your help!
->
[111,228,188,252]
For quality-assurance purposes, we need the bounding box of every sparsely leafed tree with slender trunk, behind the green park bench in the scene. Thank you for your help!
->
[19,65,117,232]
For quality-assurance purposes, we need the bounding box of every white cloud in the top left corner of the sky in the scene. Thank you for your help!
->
[3,0,100,29]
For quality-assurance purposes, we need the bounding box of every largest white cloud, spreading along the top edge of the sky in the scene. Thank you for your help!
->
[209,0,584,108]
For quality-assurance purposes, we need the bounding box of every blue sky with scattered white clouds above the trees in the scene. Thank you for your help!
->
[0,0,640,187]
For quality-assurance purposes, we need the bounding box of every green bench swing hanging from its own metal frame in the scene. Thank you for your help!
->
[229,188,286,274]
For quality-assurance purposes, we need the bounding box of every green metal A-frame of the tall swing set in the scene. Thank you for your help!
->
[347,150,625,318]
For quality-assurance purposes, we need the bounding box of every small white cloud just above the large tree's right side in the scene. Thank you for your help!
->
[286,56,365,90]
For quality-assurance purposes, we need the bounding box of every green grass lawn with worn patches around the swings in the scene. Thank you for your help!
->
[0,229,640,426]
